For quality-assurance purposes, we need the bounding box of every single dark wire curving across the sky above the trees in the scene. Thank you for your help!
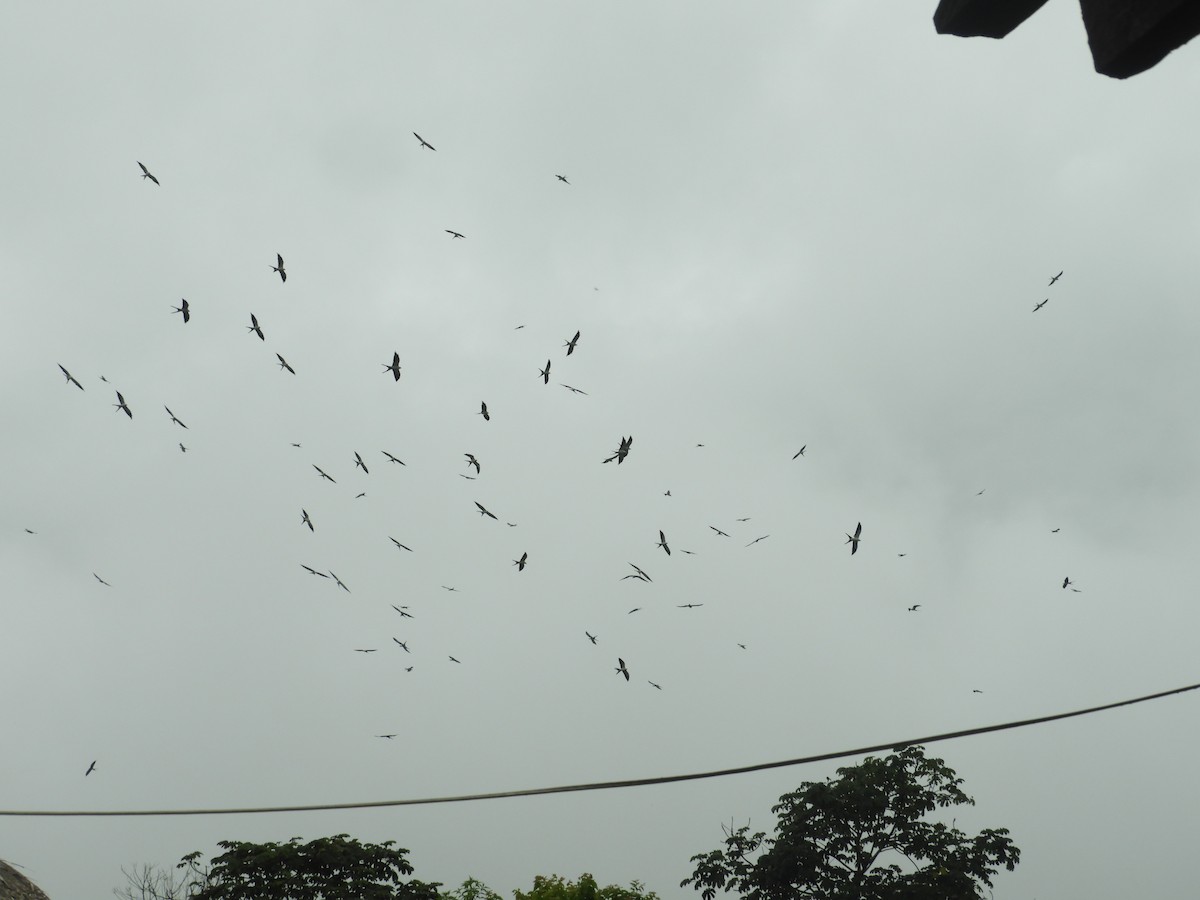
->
[0,684,1200,816]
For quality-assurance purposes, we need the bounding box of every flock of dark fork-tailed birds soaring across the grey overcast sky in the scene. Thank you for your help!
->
[39,148,1079,776]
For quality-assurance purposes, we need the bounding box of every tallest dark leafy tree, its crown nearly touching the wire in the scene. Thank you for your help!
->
[680,746,1021,900]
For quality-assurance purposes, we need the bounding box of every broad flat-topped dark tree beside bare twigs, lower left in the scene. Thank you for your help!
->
[179,834,438,900]
